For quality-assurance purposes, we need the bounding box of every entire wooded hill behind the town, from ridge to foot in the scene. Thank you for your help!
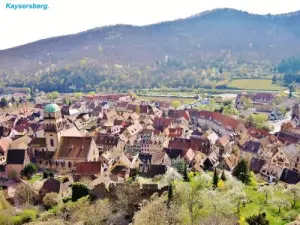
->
[0,9,300,92]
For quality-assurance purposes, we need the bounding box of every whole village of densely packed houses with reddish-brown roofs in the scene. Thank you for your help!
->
[0,92,300,225]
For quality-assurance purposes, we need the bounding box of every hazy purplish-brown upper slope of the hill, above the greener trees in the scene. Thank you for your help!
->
[0,9,300,73]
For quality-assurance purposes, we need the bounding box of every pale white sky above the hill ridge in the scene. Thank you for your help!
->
[0,0,300,49]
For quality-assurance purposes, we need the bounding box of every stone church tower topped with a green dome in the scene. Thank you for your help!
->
[44,104,64,152]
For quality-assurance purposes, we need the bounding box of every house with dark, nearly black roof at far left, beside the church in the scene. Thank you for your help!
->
[6,149,30,180]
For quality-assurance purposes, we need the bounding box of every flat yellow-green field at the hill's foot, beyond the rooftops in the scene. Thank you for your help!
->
[228,79,283,91]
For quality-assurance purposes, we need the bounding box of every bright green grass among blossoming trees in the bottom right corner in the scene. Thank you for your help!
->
[241,186,300,225]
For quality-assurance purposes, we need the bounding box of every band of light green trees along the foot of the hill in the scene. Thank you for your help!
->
[0,56,272,93]
